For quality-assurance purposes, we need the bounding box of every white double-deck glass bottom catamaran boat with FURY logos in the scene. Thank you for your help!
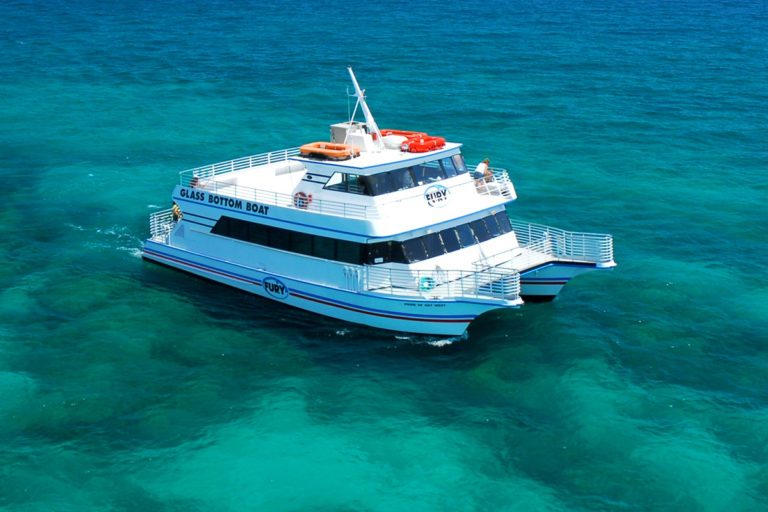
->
[142,68,616,336]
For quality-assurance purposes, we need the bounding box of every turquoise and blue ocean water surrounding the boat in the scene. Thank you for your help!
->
[0,0,768,512]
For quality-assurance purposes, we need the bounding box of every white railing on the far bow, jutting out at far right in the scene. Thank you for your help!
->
[474,220,615,270]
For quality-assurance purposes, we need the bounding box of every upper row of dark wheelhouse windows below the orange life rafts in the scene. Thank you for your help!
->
[325,155,467,196]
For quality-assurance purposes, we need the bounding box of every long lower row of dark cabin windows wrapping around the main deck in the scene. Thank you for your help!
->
[211,212,512,265]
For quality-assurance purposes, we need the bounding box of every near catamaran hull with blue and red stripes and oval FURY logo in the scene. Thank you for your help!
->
[142,239,519,336]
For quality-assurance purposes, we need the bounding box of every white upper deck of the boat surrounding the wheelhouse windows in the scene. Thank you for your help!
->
[179,144,516,228]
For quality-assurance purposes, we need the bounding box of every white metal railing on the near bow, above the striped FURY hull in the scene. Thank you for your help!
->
[364,266,520,301]
